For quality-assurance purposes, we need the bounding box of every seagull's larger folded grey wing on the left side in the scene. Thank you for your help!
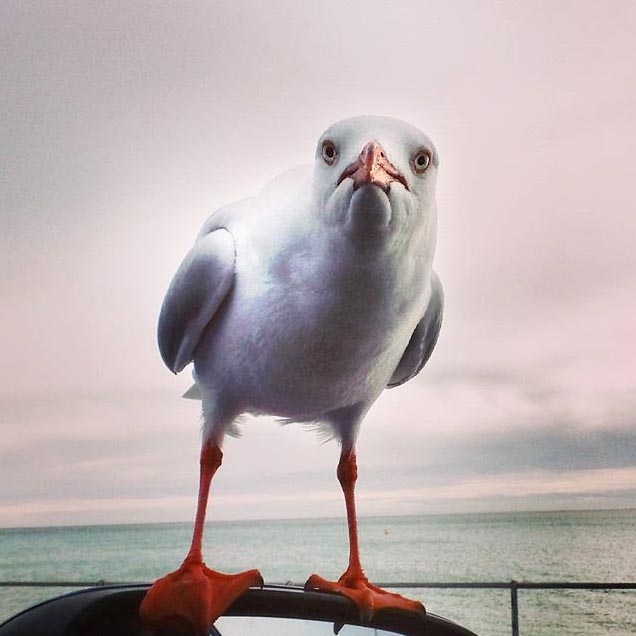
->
[157,228,235,373]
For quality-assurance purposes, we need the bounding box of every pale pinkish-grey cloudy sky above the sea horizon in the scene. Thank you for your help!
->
[0,0,636,526]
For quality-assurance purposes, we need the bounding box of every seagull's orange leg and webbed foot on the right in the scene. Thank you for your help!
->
[305,450,425,620]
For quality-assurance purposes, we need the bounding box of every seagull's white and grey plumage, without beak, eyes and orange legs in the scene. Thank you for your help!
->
[159,117,441,450]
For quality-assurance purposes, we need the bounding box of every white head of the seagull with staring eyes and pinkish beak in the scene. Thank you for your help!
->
[313,116,438,247]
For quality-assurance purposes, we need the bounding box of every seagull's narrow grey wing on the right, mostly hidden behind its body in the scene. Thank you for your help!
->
[387,272,444,388]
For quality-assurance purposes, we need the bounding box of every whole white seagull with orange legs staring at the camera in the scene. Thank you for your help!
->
[140,116,444,635]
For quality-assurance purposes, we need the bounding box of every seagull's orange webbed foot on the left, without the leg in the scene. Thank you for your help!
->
[139,559,263,636]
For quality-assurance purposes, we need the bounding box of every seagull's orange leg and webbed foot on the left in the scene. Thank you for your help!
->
[139,442,263,636]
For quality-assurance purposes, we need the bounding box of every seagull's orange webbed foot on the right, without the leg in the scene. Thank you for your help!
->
[305,571,426,622]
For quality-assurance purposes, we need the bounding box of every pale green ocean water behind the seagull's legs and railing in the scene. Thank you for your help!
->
[0,510,636,636]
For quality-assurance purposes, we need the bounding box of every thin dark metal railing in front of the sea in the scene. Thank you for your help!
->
[0,579,636,636]
